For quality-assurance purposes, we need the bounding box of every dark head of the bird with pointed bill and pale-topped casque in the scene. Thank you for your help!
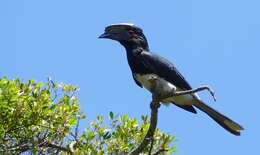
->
[99,23,148,50]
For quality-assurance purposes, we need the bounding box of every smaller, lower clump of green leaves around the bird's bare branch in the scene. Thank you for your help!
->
[77,112,175,154]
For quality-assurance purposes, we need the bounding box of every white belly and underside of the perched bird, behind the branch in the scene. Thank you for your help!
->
[135,74,197,105]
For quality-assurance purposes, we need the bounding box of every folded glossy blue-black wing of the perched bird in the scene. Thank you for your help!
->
[139,51,192,90]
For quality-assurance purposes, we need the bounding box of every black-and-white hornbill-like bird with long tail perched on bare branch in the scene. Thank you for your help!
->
[99,23,244,136]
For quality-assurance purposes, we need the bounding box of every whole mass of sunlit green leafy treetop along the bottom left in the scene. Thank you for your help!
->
[0,78,175,155]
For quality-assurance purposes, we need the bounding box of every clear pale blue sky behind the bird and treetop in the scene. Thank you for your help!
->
[0,0,260,155]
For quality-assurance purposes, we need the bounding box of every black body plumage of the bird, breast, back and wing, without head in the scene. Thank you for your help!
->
[123,47,197,113]
